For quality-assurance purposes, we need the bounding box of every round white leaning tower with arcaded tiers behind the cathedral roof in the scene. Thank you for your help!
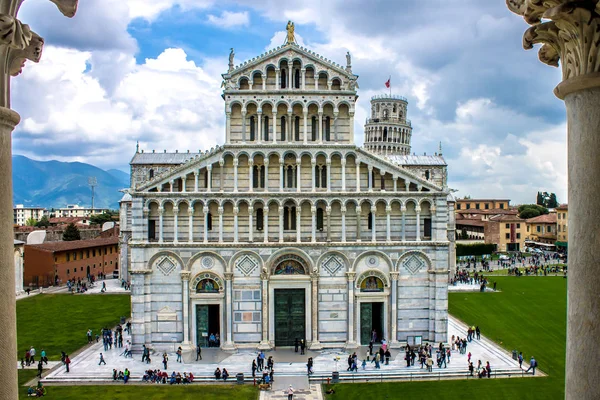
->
[365,95,412,156]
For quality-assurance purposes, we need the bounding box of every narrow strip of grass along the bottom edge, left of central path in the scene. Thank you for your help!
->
[19,382,258,400]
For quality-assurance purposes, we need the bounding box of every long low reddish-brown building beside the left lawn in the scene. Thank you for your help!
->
[23,236,119,287]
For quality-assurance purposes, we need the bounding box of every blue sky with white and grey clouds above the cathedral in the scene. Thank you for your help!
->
[11,0,567,204]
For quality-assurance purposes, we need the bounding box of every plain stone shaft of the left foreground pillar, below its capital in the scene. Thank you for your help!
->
[0,107,20,399]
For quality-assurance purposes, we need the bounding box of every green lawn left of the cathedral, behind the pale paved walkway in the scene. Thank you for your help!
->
[17,294,131,360]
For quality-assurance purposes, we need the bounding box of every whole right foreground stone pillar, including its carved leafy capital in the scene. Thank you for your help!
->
[506,0,600,399]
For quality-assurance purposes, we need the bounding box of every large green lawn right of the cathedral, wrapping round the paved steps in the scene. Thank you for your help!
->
[324,277,567,400]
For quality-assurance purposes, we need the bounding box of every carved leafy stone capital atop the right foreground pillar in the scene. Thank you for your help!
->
[506,0,600,99]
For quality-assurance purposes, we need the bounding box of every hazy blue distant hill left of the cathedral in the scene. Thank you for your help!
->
[13,155,129,209]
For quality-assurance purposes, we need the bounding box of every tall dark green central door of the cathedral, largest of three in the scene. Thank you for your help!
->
[274,289,306,346]
